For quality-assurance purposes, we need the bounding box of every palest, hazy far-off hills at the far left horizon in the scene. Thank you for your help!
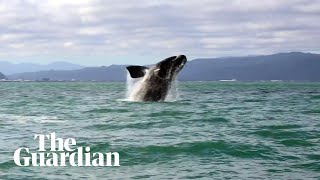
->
[0,61,84,75]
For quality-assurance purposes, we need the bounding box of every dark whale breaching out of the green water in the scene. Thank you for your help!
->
[126,55,187,101]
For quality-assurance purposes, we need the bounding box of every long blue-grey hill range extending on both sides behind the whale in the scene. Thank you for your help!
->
[9,52,320,81]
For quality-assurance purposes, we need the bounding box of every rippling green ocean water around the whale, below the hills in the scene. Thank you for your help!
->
[0,82,320,179]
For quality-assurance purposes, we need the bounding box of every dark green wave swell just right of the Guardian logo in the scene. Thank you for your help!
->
[115,141,275,167]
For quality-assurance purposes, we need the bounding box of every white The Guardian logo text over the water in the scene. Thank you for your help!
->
[13,133,120,166]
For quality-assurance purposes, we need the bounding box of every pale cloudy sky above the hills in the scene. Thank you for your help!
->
[0,0,320,66]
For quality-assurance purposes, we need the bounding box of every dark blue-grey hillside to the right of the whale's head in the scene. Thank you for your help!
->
[180,52,320,81]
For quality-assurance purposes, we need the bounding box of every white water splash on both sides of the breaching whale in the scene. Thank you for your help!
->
[125,72,179,102]
